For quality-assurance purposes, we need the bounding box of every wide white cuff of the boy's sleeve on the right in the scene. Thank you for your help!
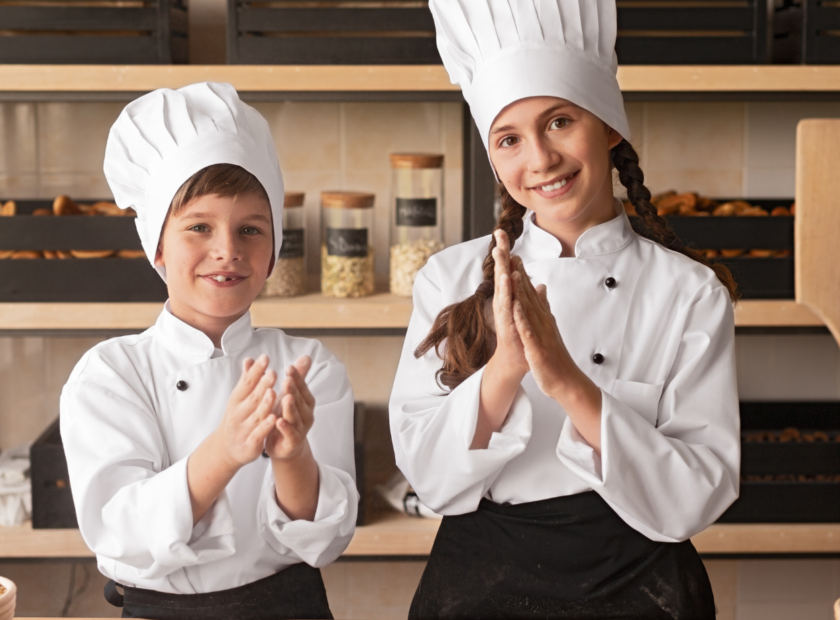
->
[260,463,359,566]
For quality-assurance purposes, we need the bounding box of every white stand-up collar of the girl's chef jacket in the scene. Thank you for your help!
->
[514,198,636,264]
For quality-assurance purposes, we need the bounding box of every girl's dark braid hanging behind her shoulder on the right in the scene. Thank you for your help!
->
[612,140,740,301]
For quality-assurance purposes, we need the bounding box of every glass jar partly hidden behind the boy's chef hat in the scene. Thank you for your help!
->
[260,192,306,297]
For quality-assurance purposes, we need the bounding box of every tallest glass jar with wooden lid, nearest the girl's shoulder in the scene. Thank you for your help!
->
[390,153,444,297]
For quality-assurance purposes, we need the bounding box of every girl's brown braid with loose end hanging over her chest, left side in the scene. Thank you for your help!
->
[414,185,526,389]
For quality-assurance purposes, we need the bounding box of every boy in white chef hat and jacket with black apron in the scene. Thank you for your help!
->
[61,84,358,619]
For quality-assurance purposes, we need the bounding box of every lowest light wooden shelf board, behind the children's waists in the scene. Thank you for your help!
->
[0,513,840,559]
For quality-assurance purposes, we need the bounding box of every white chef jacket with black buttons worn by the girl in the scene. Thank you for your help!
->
[390,201,740,542]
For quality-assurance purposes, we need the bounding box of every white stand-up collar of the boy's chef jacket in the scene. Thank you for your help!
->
[155,301,253,361]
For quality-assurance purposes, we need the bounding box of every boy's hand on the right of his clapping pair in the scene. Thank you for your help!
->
[265,355,315,460]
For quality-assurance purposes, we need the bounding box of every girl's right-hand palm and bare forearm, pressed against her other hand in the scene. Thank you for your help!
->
[511,257,601,454]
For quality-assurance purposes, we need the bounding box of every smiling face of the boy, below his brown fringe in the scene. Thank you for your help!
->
[155,194,274,329]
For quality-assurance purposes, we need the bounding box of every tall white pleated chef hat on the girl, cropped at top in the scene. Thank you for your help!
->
[429,0,630,147]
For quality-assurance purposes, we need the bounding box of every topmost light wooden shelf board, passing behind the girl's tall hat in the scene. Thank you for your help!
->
[0,65,840,93]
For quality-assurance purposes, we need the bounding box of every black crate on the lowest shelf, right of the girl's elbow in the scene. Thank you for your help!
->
[719,402,840,523]
